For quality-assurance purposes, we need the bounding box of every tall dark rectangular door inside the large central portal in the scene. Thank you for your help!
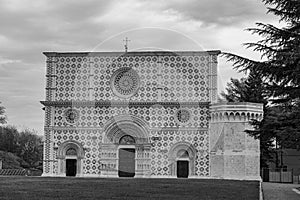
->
[118,148,135,177]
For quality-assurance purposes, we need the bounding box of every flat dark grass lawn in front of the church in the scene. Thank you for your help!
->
[0,177,259,200]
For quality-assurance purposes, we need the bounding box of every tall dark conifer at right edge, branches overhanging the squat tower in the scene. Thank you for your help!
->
[223,0,300,167]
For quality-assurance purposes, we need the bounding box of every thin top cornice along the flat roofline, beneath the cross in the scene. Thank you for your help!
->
[43,50,221,57]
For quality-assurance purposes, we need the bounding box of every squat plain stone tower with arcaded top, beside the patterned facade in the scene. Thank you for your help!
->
[209,103,263,179]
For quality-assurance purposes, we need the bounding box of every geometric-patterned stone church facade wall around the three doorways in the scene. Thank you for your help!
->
[42,51,220,177]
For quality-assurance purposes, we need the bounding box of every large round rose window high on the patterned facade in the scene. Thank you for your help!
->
[110,67,140,98]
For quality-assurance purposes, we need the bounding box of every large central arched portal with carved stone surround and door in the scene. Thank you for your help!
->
[100,115,151,177]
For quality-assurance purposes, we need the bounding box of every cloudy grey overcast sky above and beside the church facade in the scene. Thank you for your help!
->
[0,0,277,134]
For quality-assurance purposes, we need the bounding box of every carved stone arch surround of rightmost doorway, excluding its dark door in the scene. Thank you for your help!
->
[169,142,196,176]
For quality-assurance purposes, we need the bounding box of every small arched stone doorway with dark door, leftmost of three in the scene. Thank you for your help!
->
[57,140,84,176]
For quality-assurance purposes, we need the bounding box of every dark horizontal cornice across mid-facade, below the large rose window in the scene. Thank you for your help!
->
[41,101,210,107]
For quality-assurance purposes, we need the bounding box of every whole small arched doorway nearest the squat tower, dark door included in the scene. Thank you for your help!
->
[169,142,196,178]
